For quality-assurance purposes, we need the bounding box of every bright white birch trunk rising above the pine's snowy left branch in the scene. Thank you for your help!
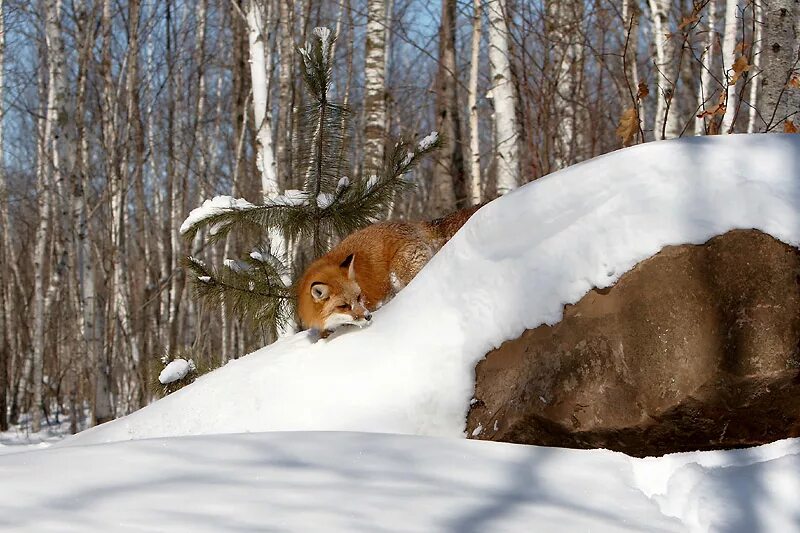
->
[247,0,279,198]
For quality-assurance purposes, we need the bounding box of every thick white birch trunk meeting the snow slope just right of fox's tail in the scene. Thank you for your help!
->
[486,0,520,196]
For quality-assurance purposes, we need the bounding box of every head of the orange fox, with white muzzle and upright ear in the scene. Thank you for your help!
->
[299,254,372,332]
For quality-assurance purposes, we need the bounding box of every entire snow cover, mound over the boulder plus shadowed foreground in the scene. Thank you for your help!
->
[6,135,800,532]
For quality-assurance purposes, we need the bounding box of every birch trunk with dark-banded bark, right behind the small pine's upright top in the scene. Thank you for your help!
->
[364,0,386,175]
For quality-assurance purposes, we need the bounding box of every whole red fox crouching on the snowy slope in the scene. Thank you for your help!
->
[297,205,481,338]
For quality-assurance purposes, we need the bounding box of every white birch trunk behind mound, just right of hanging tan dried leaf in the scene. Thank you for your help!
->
[649,0,681,139]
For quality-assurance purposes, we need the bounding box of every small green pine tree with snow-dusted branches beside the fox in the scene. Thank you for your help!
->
[181,28,441,338]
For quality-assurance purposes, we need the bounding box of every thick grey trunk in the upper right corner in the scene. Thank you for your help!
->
[759,0,800,132]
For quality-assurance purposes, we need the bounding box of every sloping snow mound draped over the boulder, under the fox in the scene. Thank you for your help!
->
[67,135,800,443]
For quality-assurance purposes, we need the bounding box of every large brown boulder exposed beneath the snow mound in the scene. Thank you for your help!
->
[467,230,800,456]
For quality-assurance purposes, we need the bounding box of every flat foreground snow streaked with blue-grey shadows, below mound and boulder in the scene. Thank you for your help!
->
[0,432,800,533]
